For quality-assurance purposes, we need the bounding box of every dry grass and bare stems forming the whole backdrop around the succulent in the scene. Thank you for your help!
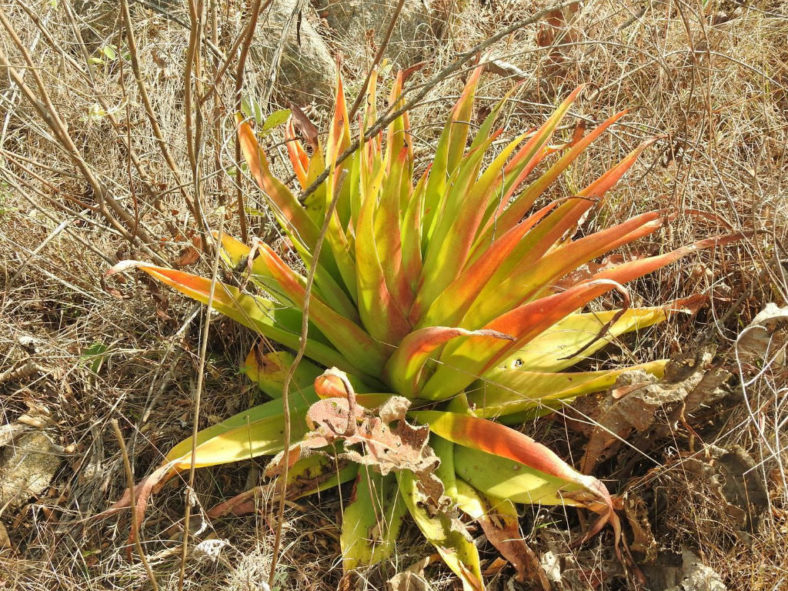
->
[0,0,788,590]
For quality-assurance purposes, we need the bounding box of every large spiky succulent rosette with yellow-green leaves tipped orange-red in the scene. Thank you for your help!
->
[107,68,732,589]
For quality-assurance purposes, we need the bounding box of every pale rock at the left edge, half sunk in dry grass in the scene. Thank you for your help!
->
[0,431,62,508]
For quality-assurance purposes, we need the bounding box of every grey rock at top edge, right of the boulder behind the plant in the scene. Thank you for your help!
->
[315,0,436,68]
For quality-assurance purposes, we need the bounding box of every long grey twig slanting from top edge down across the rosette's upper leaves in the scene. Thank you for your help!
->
[298,0,580,201]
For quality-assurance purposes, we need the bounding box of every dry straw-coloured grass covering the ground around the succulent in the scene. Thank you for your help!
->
[0,0,788,591]
